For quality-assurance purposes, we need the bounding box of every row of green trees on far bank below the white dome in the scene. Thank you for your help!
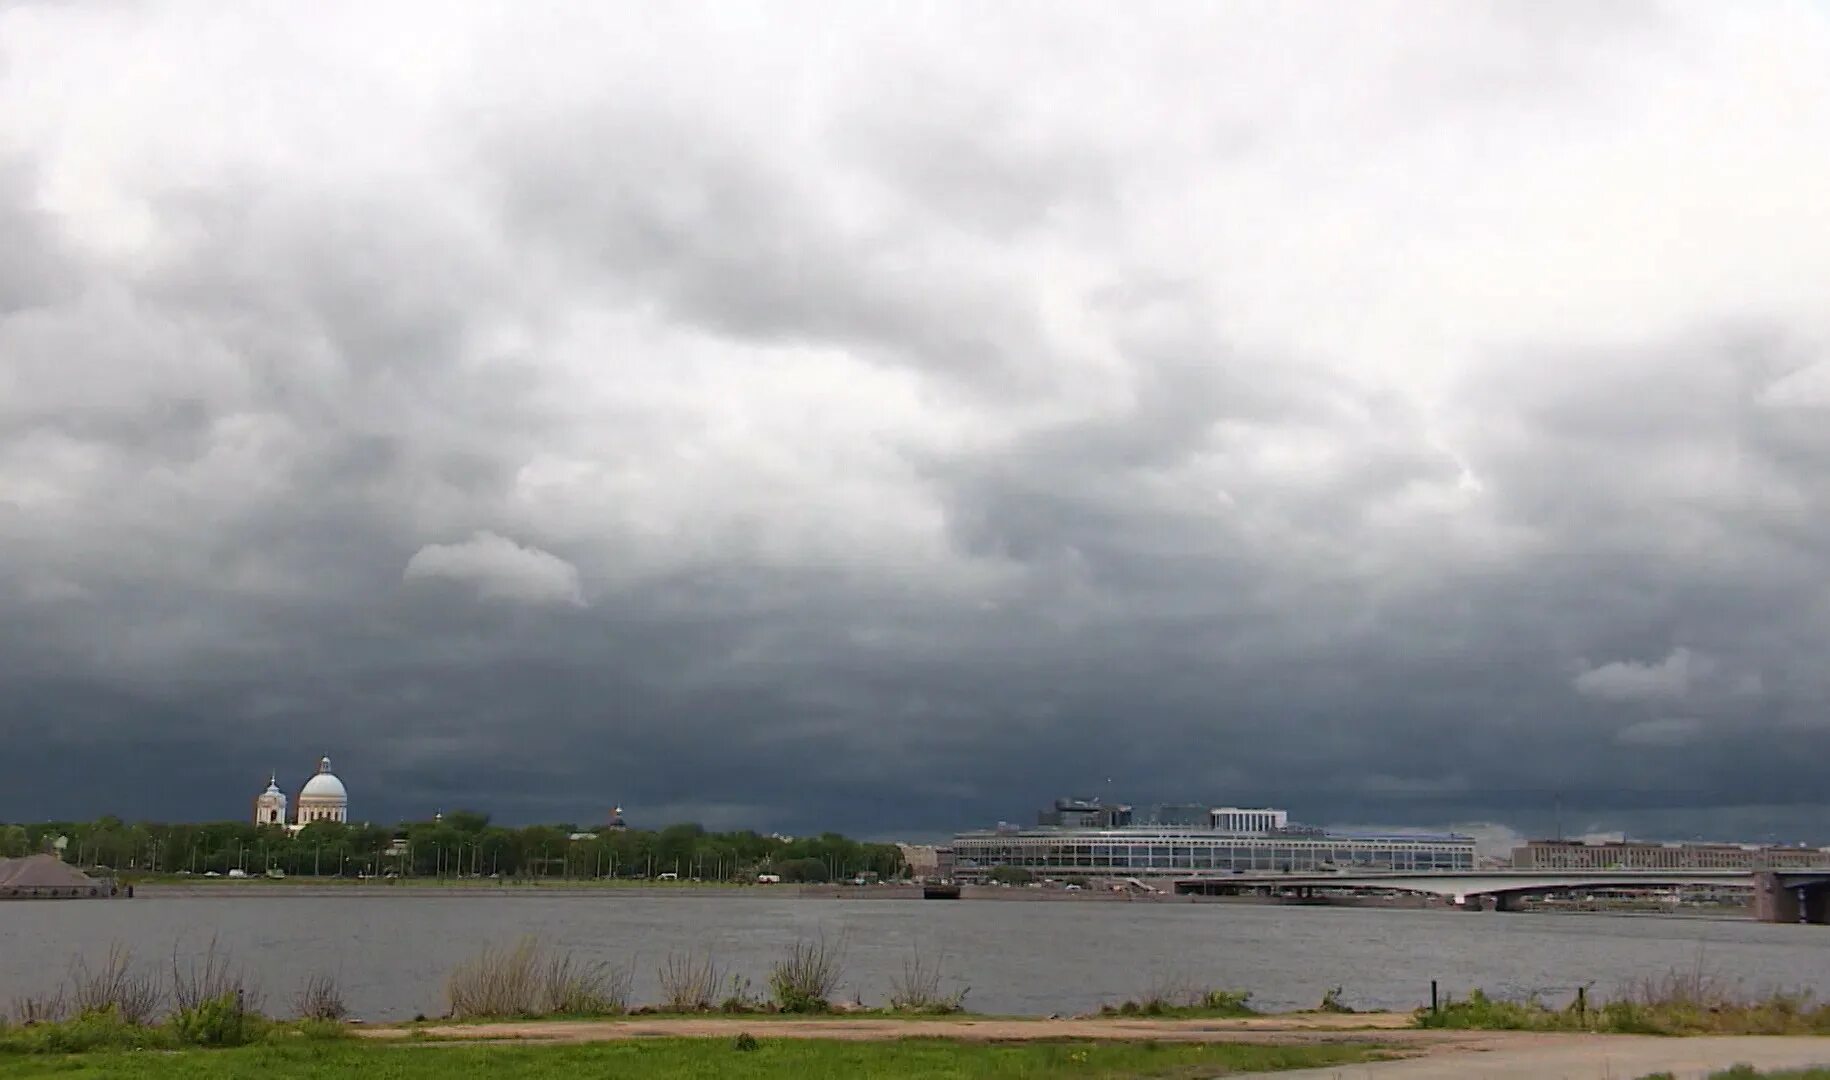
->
[0,811,906,882]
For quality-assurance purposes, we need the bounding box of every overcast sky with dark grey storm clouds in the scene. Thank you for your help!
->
[0,0,1830,842]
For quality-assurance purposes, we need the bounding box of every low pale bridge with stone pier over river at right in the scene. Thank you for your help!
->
[1175,868,1830,923]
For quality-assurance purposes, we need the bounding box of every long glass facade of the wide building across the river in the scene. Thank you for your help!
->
[953,829,1475,880]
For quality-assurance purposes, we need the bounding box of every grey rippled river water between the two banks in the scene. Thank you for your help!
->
[0,890,1830,1020]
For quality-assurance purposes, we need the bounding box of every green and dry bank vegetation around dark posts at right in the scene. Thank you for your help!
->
[1416,970,1830,1034]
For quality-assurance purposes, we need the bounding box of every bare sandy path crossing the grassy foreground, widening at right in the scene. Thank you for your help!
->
[361,1012,1830,1080]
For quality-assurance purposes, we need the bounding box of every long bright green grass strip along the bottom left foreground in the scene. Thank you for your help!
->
[4,1032,1385,1080]
